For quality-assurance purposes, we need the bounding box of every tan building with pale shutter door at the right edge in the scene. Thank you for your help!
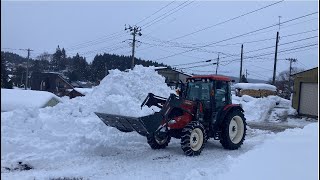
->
[291,67,319,117]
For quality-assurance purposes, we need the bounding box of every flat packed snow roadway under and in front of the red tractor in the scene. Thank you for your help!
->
[1,127,268,179]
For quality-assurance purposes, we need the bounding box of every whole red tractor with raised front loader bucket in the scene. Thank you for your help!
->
[96,75,246,156]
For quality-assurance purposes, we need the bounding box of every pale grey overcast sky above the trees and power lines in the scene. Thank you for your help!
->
[1,0,319,80]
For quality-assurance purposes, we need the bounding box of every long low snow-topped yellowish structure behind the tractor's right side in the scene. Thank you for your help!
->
[234,83,277,98]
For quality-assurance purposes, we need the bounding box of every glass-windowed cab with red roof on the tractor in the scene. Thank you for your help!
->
[184,75,232,119]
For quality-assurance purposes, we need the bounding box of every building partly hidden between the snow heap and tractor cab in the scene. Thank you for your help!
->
[155,67,192,86]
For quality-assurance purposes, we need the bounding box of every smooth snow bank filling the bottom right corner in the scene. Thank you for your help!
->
[213,123,319,180]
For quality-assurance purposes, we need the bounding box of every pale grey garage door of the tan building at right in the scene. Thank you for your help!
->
[299,83,318,116]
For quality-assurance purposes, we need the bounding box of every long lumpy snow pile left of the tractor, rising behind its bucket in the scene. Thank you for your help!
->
[1,66,173,174]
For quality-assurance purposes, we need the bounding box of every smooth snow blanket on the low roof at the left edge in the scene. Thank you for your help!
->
[1,89,61,111]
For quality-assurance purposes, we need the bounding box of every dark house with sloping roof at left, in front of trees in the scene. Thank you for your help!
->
[30,72,73,97]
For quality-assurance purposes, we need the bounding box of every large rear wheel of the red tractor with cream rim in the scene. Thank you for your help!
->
[220,110,247,150]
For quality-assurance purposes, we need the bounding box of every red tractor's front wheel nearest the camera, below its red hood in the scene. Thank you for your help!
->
[181,122,207,156]
